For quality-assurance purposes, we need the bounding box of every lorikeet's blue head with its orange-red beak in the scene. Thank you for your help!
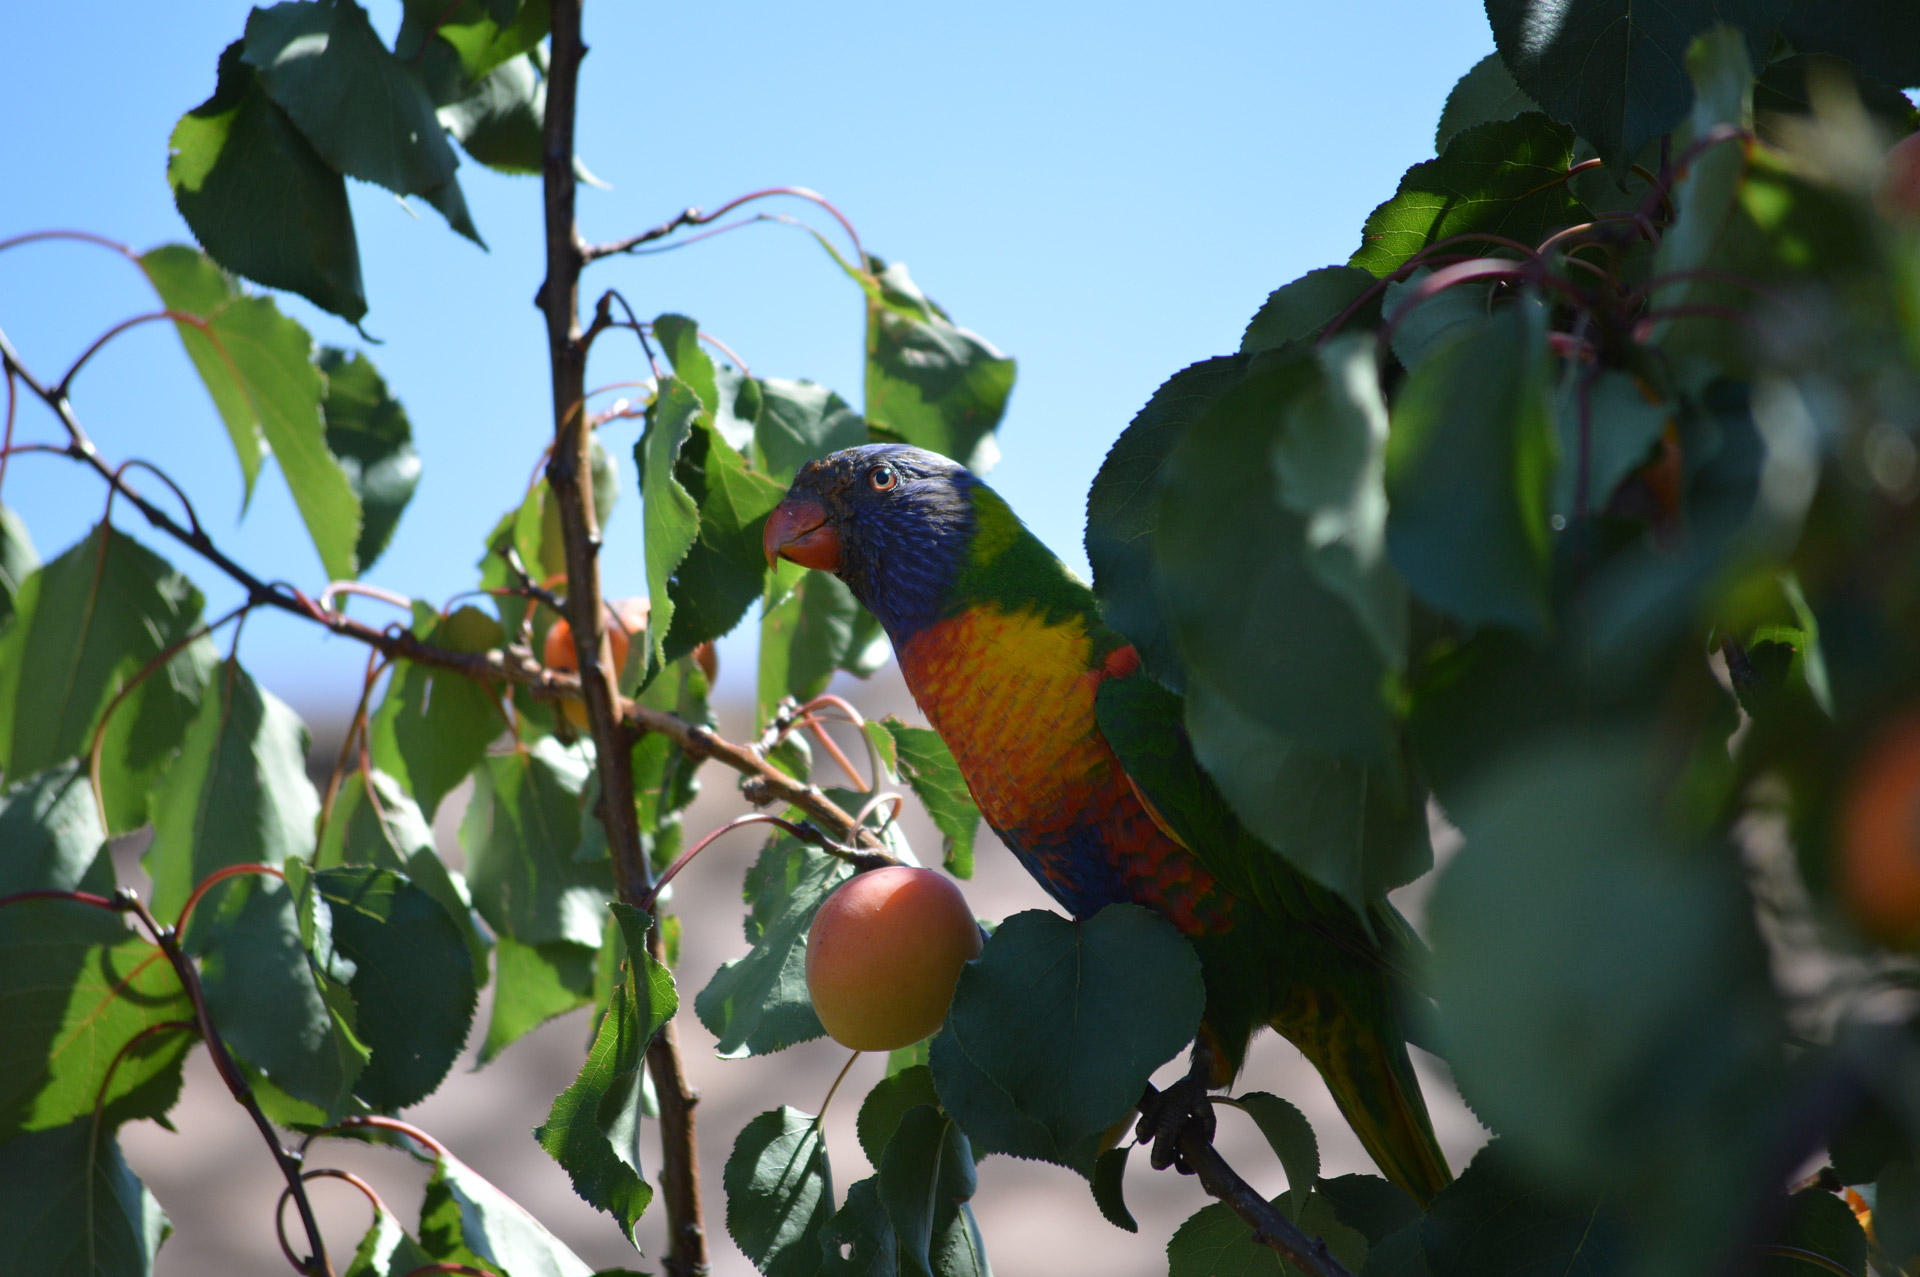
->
[762,444,979,645]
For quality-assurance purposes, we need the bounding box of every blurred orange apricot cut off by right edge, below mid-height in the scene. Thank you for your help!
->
[1839,712,1920,947]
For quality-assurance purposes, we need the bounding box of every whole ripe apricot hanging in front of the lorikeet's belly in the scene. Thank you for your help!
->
[806,864,979,1050]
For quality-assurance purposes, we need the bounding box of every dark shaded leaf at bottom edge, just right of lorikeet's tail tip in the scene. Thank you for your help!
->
[1421,1139,1628,1277]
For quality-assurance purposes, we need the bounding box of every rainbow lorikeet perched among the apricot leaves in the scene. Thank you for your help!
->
[764,444,1452,1202]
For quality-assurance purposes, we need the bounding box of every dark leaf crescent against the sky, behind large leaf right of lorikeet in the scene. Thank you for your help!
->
[1087,349,1251,691]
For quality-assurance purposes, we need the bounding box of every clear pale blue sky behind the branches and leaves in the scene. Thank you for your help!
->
[0,0,1492,716]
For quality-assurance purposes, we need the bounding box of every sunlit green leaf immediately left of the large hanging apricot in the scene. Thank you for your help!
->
[693,835,852,1058]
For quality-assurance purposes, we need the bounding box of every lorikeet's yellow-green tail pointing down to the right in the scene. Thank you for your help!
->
[1273,991,1453,1206]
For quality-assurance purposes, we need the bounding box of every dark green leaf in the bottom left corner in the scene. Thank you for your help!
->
[0,1118,173,1277]
